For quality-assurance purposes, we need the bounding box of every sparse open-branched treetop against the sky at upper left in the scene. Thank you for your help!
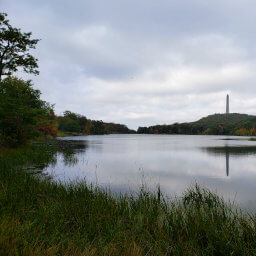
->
[0,13,39,81]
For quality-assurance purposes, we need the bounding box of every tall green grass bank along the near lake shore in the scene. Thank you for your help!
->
[0,144,256,256]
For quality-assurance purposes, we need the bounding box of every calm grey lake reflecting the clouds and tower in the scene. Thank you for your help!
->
[41,135,256,210]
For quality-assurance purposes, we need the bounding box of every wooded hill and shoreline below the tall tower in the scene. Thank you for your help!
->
[137,113,256,136]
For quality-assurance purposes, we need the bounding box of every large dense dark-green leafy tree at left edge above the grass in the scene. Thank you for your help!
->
[0,77,53,146]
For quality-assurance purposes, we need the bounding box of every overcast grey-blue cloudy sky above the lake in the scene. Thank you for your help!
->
[0,0,256,128]
